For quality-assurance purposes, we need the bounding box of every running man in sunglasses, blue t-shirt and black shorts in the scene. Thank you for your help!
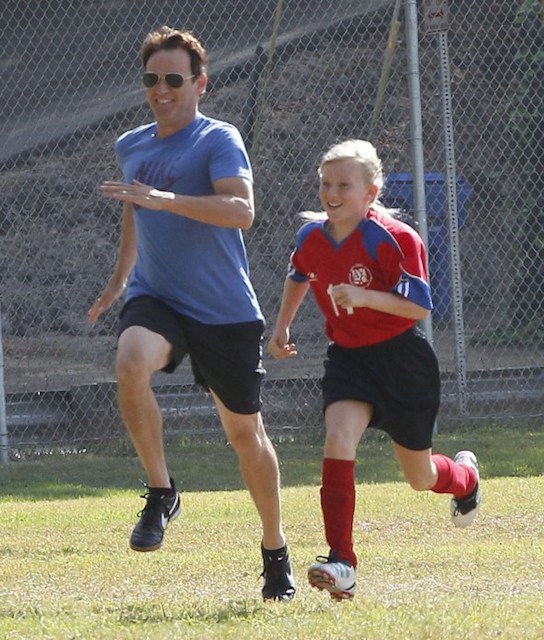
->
[89,27,295,600]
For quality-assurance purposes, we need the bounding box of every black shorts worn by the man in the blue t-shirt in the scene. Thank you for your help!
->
[118,296,265,414]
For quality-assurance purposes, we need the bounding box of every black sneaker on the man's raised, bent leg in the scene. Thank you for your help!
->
[130,478,181,551]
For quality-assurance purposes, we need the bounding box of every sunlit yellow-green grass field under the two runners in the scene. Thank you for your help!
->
[0,427,544,640]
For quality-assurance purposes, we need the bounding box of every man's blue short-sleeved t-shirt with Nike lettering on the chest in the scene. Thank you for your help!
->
[115,113,263,324]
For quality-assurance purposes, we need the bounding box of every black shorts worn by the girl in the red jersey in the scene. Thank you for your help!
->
[322,330,440,451]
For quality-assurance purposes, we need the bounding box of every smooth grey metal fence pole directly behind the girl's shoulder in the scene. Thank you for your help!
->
[404,0,433,344]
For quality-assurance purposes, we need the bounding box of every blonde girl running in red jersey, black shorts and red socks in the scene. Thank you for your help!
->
[268,140,481,600]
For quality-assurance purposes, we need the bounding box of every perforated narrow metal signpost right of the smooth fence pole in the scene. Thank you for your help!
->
[437,31,467,415]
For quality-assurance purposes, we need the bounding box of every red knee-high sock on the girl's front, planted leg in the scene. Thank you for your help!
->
[321,458,357,567]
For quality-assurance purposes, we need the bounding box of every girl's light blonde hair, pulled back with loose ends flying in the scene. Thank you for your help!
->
[300,139,397,220]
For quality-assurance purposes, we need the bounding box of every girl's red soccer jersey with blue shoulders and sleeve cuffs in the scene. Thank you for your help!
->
[289,209,433,348]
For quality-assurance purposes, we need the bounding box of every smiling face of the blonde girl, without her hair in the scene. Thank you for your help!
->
[319,158,378,224]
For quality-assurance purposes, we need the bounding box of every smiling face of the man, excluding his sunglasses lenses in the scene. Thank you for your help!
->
[145,49,207,136]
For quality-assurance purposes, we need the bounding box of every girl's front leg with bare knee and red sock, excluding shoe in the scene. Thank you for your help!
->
[321,400,372,568]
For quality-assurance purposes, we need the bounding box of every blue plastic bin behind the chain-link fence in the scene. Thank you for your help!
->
[381,172,473,320]
